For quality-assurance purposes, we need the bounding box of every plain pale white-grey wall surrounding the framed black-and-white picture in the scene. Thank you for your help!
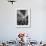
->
[0,0,46,41]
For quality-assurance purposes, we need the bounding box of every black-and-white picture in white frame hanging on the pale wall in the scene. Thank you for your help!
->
[16,8,31,27]
